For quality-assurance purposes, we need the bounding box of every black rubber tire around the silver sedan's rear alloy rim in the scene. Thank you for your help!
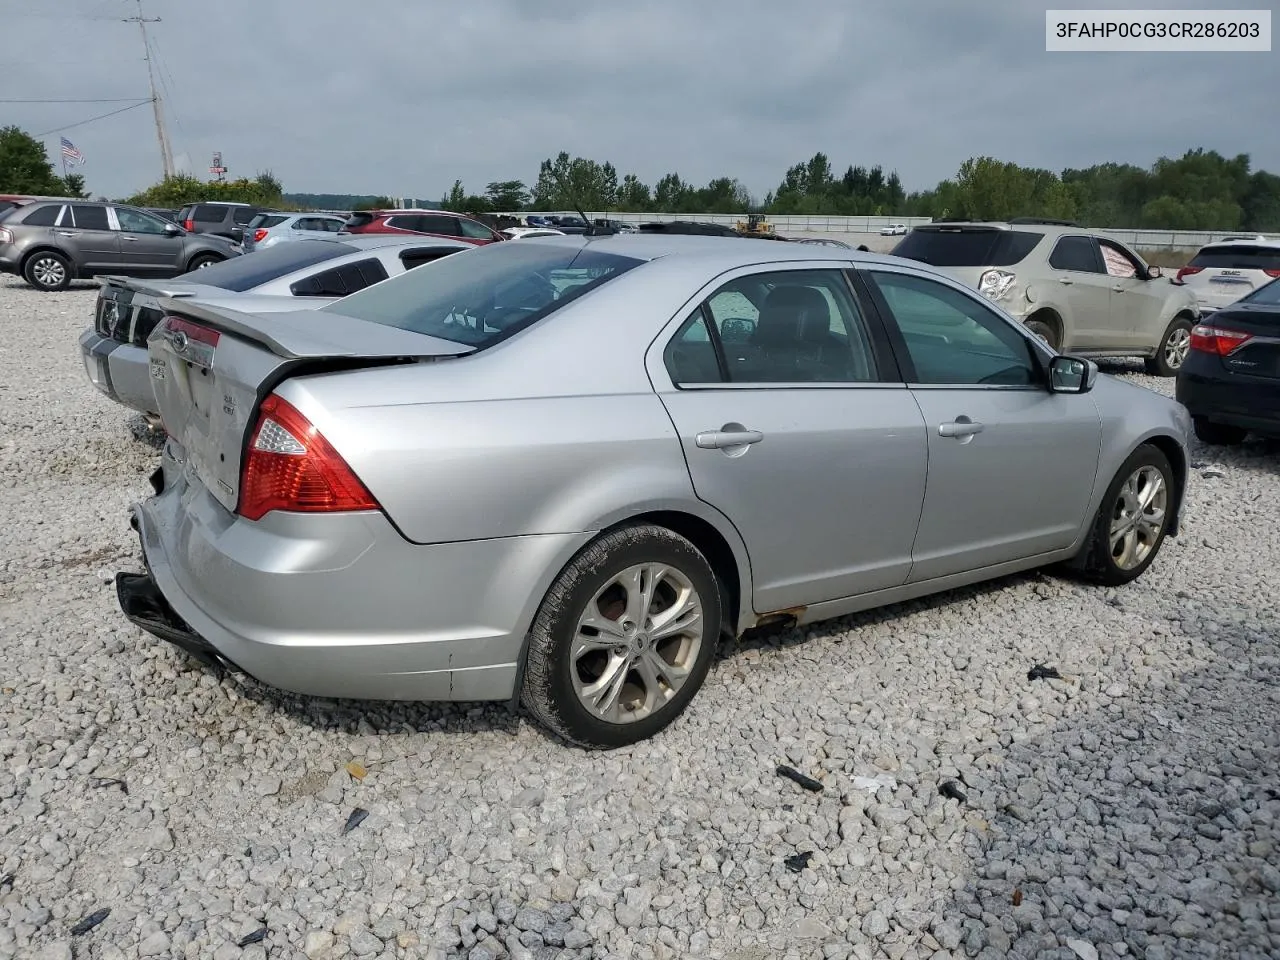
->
[520,525,722,750]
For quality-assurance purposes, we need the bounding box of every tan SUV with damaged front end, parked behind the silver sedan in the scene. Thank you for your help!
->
[893,219,1199,376]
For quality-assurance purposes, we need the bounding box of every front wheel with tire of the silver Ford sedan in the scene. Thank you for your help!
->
[1073,444,1176,586]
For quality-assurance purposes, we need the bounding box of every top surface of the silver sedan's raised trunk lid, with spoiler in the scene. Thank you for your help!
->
[159,297,475,360]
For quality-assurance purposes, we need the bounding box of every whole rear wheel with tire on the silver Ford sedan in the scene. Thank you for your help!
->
[521,525,721,749]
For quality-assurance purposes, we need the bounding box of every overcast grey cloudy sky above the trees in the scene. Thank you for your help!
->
[0,0,1280,198]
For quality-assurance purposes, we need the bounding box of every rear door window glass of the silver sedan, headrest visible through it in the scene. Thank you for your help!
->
[684,270,877,383]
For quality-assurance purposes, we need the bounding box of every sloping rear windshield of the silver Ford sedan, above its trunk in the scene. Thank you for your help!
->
[320,243,644,349]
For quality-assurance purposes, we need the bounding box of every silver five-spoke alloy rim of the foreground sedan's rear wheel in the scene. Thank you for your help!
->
[570,563,705,723]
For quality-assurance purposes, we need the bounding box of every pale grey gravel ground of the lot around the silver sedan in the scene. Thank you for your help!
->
[0,272,1280,960]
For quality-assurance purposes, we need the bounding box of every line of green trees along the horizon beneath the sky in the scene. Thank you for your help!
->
[0,127,1280,233]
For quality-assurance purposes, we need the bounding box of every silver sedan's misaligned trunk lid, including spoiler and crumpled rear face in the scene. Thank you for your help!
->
[147,298,474,511]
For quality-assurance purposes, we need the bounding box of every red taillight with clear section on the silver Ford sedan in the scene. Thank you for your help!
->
[236,393,379,520]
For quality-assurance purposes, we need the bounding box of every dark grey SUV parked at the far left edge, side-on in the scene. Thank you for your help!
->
[0,201,241,291]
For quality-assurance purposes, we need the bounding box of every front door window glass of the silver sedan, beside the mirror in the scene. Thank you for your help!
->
[867,270,1039,387]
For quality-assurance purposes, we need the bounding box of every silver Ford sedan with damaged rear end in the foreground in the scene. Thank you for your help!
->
[116,234,1189,748]
